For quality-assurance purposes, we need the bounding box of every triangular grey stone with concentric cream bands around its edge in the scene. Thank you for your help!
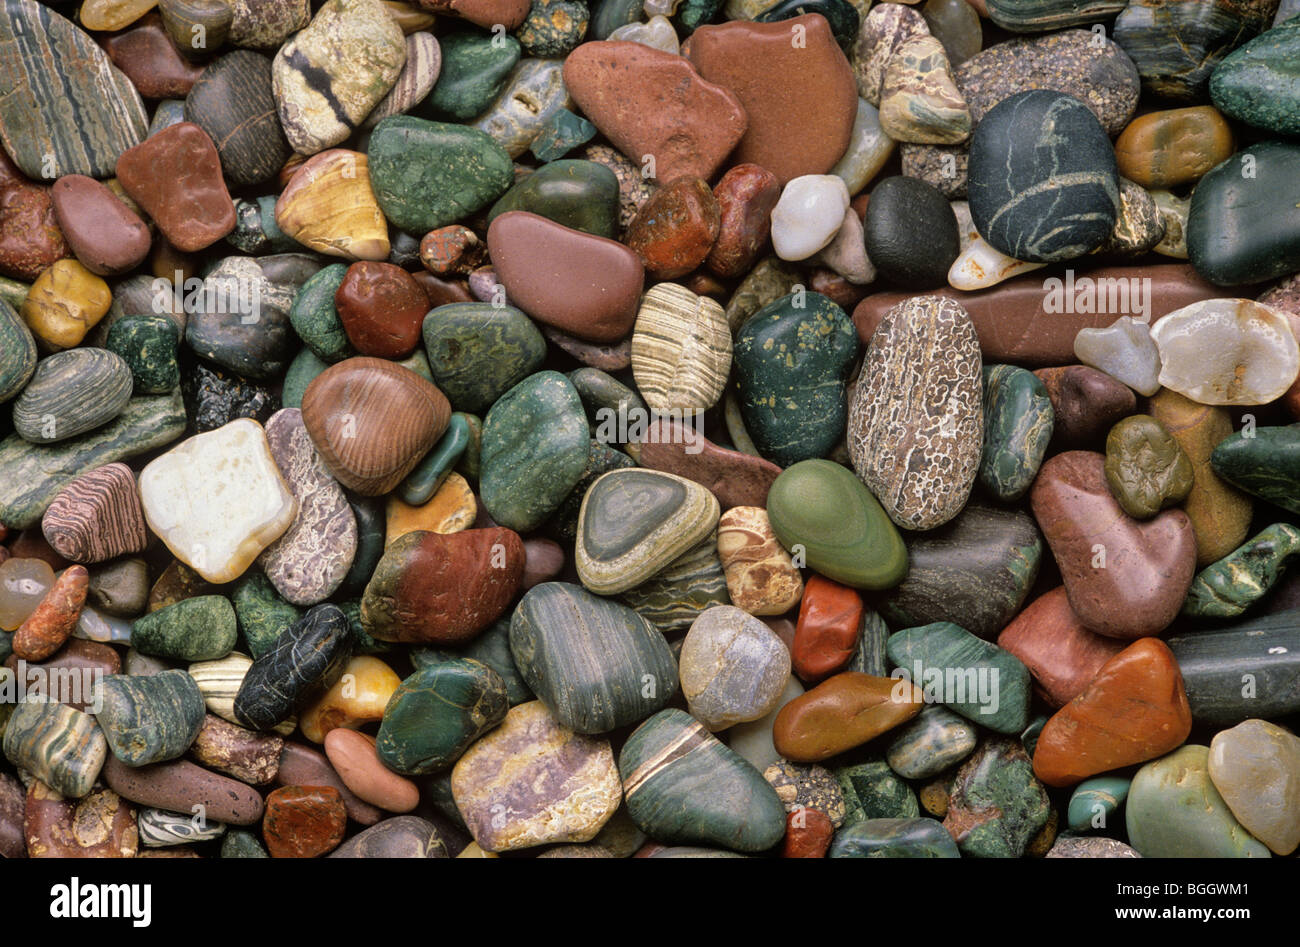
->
[576,470,720,594]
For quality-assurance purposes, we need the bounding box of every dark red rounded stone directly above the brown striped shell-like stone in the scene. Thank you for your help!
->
[334,260,429,359]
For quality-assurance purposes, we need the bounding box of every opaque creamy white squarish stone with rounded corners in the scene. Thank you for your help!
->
[140,418,298,584]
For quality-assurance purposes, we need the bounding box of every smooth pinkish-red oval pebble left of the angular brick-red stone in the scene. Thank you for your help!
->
[51,174,150,276]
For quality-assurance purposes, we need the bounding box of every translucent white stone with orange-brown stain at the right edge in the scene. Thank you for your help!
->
[1151,299,1300,405]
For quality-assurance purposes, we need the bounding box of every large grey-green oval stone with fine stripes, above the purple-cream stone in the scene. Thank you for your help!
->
[510,583,677,734]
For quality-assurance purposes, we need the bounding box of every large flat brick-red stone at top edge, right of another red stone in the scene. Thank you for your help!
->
[685,13,858,186]
